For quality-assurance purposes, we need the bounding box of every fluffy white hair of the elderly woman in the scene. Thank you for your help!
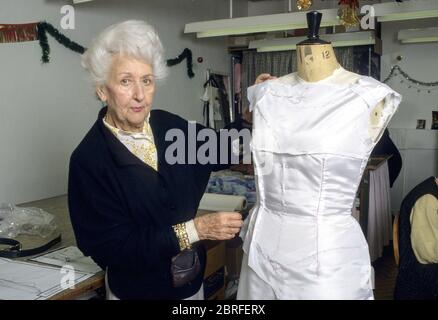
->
[82,20,167,85]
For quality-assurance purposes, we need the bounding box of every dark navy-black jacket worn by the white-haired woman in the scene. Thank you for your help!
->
[68,108,243,299]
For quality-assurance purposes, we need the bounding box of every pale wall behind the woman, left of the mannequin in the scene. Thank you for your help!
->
[0,0,229,203]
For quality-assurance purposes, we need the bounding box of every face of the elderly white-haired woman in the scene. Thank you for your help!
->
[96,55,155,132]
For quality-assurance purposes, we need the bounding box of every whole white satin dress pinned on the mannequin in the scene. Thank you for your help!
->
[237,68,401,300]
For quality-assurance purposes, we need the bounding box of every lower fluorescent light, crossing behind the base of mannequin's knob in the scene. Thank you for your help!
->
[248,31,376,52]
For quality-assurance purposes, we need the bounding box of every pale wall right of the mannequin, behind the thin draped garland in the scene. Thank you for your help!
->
[381,19,438,211]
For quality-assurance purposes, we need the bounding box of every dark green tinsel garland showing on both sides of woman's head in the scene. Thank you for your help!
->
[38,22,195,78]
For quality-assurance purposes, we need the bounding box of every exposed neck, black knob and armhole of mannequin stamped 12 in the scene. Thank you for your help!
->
[279,11,385,140]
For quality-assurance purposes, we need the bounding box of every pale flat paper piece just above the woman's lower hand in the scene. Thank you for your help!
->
[199,193,246,211]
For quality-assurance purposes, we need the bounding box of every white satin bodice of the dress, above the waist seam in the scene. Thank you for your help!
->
[248,70,400,220]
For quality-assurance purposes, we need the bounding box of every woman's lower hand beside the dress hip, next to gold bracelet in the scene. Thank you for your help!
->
[194,212,243,240]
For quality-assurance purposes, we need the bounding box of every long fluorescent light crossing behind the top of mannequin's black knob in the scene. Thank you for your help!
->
[184,9,340,38]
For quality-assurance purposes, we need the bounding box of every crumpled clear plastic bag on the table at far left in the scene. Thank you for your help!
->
[0,204,57,238]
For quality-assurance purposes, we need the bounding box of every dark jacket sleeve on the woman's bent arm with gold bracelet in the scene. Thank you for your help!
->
[68,156,179,272]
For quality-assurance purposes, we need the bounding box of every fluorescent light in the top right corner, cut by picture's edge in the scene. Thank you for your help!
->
[372,0,438,22]
